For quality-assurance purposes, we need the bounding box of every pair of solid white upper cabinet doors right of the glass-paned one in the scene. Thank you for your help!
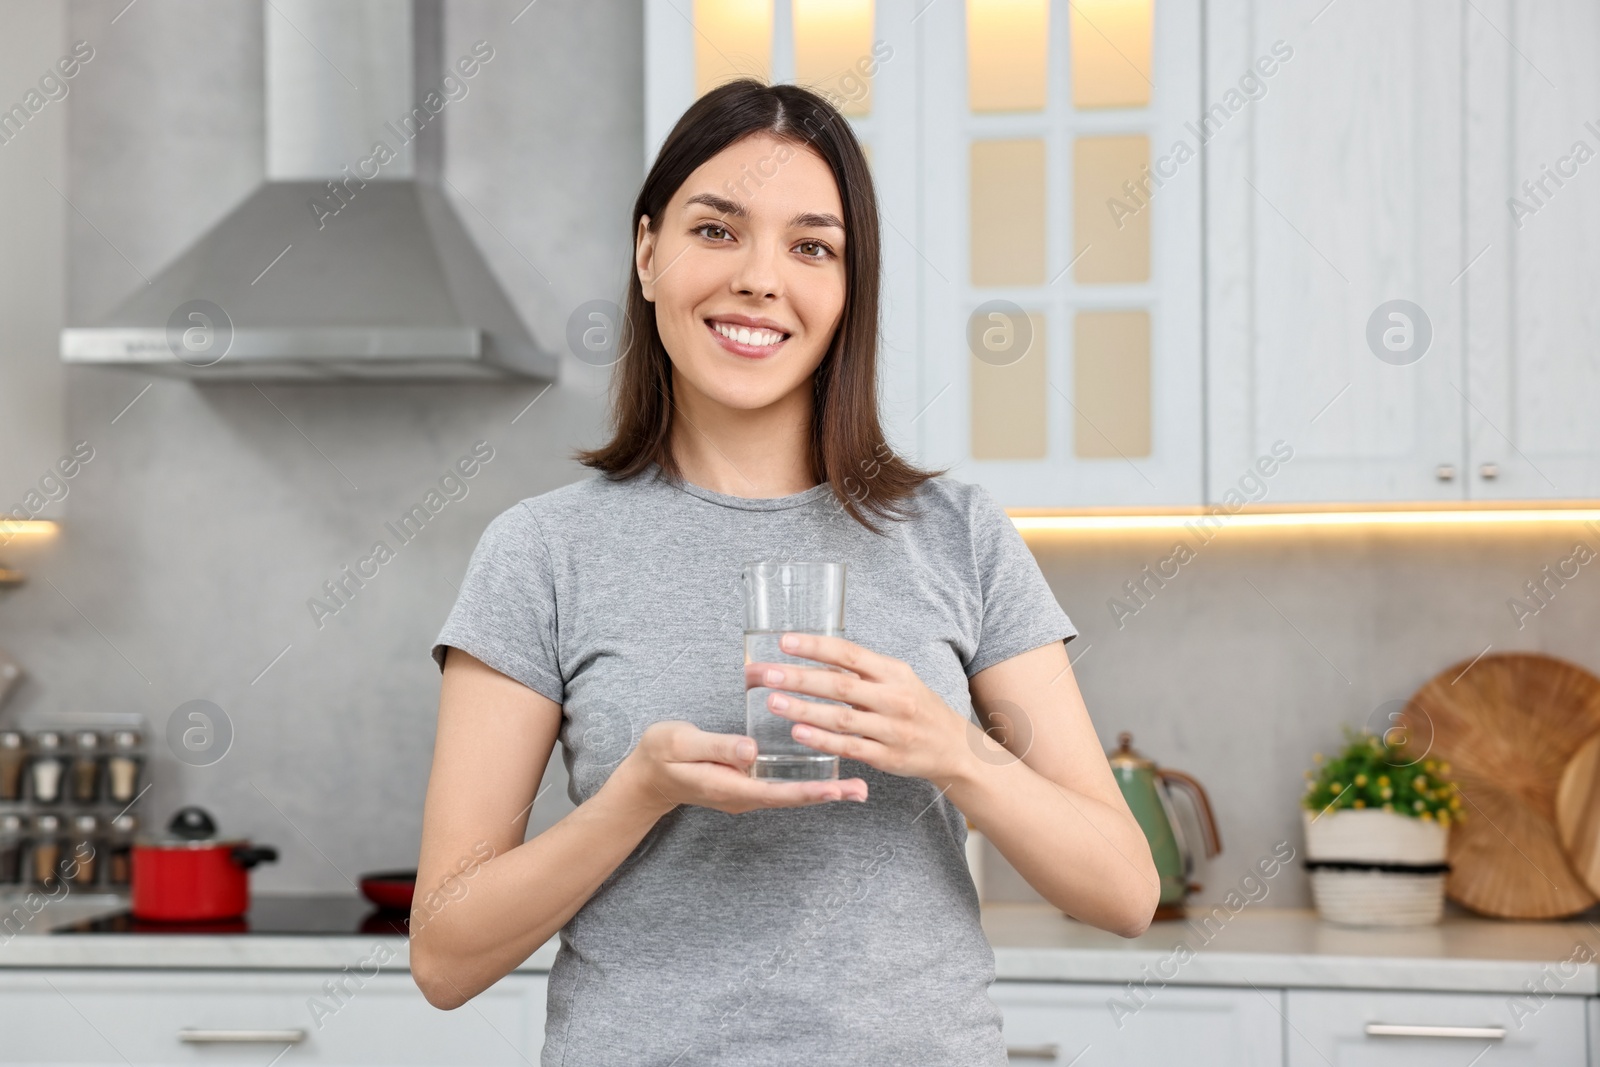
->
[1206,0,1600,502]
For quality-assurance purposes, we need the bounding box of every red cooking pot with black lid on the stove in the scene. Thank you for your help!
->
[133,808,278,923]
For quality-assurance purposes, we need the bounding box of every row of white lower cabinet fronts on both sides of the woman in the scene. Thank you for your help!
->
[0,966,1600,1067]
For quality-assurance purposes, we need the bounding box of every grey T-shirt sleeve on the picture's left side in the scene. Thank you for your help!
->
[434,502,565,704]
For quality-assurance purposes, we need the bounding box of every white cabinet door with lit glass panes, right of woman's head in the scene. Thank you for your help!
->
[915,0,1203,507]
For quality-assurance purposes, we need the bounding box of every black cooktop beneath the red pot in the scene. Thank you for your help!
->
[50,893,410,937]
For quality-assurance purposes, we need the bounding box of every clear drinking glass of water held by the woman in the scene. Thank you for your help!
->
[741,560,845,781]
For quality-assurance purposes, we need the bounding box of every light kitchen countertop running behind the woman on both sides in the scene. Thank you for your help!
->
[0,899,1600,995]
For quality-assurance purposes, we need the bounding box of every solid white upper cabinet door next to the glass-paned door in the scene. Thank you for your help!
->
[1206,0,1477,504]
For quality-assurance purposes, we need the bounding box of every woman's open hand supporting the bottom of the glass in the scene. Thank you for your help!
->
[613,720,867,814]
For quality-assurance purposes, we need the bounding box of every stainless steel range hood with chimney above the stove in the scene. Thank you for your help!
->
[61,0,560,381]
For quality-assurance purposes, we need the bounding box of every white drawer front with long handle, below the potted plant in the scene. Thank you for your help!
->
[1286,989,1589,1067]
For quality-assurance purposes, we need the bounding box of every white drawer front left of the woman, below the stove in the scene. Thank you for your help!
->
[0,966,546,1067]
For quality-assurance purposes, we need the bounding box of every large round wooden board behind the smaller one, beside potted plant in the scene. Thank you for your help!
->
[1402,653,1600,918]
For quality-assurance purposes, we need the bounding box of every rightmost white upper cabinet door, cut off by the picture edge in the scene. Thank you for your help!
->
[1458,0,1600,499]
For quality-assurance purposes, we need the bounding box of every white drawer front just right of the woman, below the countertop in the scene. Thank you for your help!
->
[989,982,1280,1067]
